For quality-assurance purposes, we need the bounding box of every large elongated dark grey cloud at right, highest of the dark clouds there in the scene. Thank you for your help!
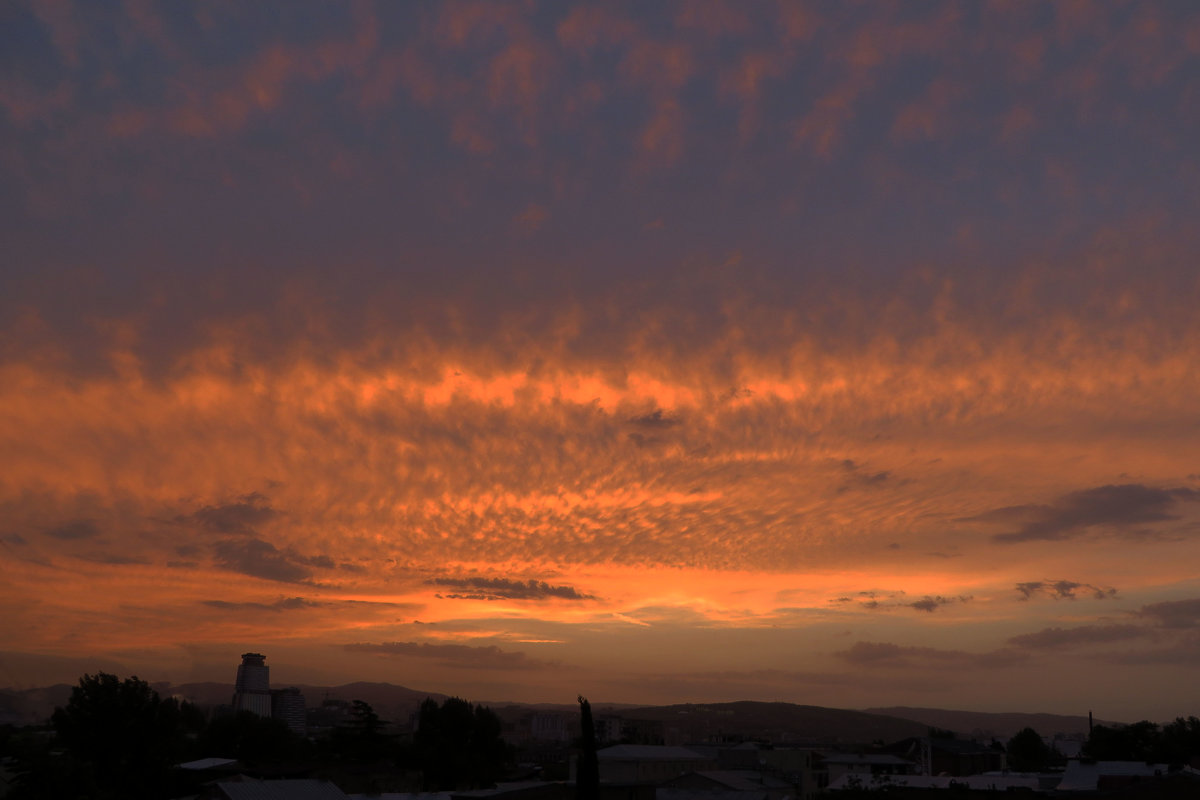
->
[962,483,1200,543]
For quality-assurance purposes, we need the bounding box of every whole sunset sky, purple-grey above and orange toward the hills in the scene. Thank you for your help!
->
[0,0,1200,721]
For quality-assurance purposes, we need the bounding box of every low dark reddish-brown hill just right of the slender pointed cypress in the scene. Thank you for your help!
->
[609,700,929,744]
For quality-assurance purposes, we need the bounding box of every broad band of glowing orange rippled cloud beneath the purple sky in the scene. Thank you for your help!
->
[7,297,1195,690]
